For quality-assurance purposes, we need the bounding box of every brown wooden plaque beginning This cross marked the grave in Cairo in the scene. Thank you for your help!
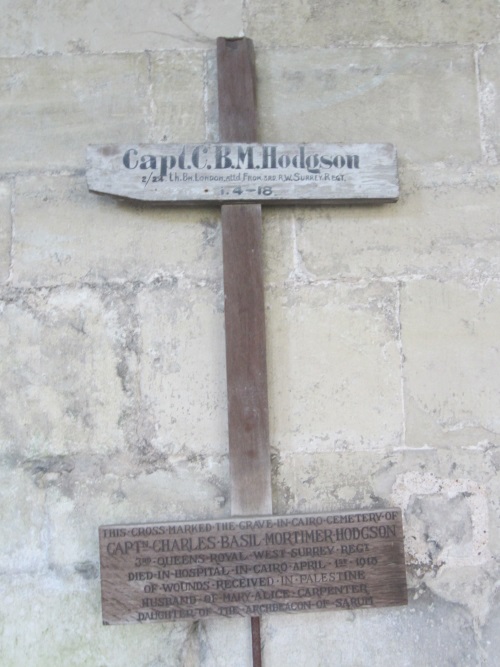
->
[99,509,407,624]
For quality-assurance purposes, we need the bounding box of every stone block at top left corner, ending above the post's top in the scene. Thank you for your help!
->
[0,0,241,56]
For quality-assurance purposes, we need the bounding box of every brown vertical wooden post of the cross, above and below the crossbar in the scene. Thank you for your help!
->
[217,37,272,515]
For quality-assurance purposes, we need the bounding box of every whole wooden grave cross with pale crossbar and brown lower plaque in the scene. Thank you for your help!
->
[87,38,407,667]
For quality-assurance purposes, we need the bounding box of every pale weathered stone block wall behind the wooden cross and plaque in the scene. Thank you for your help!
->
[0,0,500,667]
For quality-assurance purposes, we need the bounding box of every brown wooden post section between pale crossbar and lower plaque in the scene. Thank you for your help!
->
[222,206,272,515]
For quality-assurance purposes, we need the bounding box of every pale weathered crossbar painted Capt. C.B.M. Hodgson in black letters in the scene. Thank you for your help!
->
[87,143,399,204]
